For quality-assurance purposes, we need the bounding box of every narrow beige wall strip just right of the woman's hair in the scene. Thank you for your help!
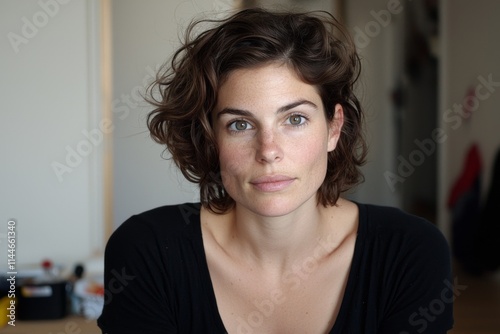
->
[344,0,405,207]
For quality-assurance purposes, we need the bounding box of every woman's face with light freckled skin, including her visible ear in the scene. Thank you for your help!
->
[212,64,343,217]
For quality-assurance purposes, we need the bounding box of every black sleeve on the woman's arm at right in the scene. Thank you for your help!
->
[378,219,455,334]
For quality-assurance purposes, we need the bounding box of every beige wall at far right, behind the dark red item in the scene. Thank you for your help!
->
[439,0,500,240]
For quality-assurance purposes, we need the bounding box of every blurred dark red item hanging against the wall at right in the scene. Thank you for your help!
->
[448,144,482,208]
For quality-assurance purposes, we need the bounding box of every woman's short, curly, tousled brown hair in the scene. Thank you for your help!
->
[147,8,367,213]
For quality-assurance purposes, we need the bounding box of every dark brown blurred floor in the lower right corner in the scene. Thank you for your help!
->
[449,265,500,334]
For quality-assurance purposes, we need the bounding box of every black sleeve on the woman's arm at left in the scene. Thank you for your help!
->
[97,216,177,334]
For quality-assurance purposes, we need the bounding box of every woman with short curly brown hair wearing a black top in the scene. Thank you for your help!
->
[98,9,453,334]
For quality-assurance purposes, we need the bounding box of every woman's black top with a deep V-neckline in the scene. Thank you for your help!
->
[98,204,455,334]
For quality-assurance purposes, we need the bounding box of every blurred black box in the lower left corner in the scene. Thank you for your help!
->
[16,281,68,320]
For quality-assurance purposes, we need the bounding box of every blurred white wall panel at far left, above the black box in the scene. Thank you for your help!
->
[0,0,104,272]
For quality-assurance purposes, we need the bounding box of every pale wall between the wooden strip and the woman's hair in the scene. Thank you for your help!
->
[112,0,228,227]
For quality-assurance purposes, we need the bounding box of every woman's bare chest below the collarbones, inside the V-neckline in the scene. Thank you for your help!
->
[208,249,350,334]
